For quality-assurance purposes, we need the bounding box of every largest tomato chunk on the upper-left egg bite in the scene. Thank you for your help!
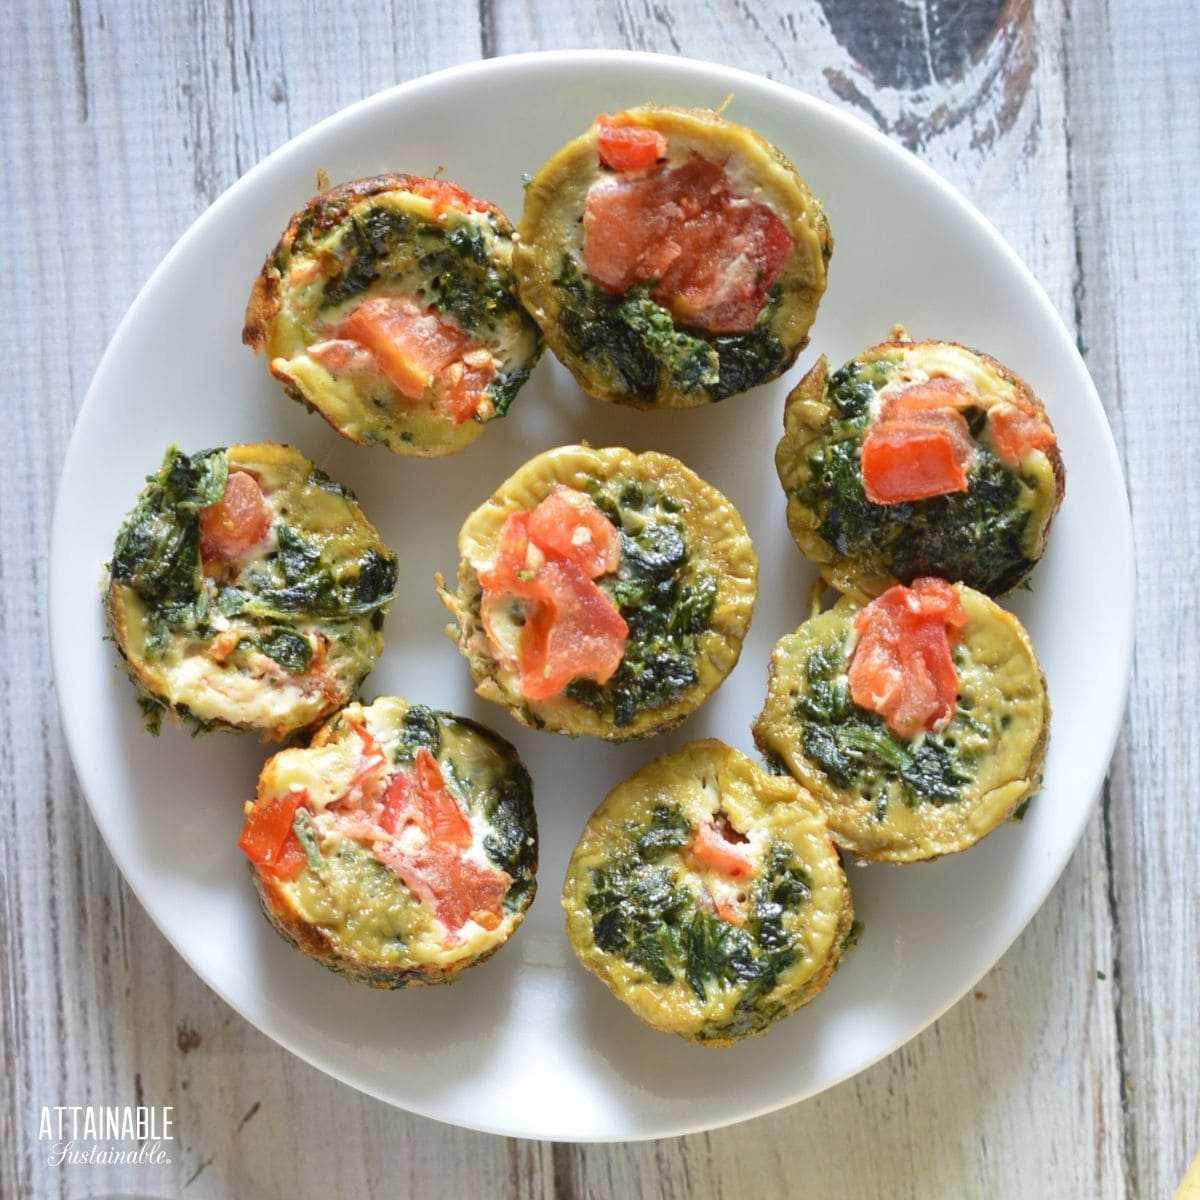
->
[337,296,467,400]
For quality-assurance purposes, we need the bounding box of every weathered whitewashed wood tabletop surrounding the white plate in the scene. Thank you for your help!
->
[0,0,1200,1200]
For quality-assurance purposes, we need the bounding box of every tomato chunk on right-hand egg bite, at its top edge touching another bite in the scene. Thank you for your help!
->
[850,576,967,738]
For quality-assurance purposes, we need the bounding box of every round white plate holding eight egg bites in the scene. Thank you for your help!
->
[50,52,1133,1140]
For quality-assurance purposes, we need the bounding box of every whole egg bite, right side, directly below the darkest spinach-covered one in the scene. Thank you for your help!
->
[754,578,1050,863]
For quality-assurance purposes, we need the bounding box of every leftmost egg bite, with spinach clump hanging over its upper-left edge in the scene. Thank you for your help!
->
[104,443,396,742]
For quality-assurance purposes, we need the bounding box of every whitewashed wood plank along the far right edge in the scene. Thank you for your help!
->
[1067,2,1200,1196]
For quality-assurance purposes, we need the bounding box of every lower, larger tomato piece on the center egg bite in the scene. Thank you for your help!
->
[521,559,629,700]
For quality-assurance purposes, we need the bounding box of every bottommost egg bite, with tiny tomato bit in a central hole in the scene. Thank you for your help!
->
[563,739,852,1045]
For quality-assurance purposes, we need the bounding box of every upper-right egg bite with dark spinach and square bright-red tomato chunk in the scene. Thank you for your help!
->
[775,326,1066,599]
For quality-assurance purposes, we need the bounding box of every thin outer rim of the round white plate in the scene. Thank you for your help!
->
[46,49,1136,1144]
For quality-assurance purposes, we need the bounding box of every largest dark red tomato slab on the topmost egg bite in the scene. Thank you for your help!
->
[583,155,794,334]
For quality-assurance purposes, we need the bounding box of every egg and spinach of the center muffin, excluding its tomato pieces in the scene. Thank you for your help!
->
[438,445,758,742]
